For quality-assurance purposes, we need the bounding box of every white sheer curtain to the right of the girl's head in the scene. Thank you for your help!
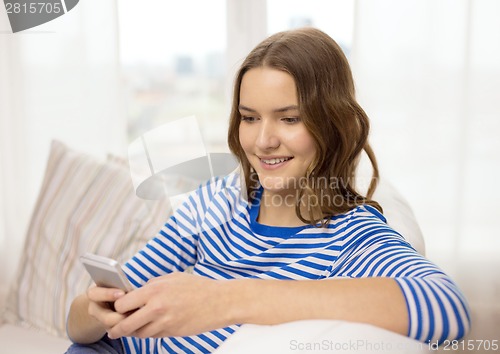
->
[351,0,500,258]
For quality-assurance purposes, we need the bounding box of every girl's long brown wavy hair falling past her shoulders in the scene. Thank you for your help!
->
[228,28,382,225]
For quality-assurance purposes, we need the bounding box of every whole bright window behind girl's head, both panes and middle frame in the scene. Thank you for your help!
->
[118,0,354,151]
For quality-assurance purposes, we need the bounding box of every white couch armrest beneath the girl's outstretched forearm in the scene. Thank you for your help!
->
[216,320,431,354]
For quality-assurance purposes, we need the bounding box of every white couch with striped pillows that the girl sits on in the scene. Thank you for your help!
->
[0,141,427,354]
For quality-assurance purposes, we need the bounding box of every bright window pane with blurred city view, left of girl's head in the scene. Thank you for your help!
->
[118,0,227,149]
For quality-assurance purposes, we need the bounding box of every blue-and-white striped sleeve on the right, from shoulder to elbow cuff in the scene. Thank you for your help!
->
[331,206,470,343]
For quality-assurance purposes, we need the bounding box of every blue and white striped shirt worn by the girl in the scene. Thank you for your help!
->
[122,174,470,353]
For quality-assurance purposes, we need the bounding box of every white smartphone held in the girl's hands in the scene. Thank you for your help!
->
[80,253,134,293]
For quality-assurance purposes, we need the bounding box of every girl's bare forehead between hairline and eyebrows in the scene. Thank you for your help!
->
[240,67,298,109]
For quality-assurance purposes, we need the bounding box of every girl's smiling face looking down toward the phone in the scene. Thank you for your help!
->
[239,67,316,194]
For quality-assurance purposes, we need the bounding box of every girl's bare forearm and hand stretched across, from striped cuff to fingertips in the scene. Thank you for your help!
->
[108,273,408,338]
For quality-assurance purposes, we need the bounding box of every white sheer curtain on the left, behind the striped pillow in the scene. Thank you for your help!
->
[0,0,126,295]
